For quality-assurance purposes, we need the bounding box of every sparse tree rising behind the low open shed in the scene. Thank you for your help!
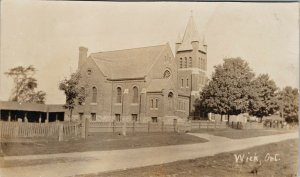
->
[5,65,46,104]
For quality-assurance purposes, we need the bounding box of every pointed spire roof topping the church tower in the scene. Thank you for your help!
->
[178,16,203,51]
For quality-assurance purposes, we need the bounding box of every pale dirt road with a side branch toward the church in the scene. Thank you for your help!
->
[0,132,298,177]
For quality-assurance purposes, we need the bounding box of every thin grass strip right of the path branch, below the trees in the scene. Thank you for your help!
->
[191,128,296,139]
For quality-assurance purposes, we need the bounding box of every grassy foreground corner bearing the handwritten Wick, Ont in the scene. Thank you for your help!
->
[75,139,298,177]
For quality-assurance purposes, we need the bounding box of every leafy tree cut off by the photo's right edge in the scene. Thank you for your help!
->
[278,86,299,123]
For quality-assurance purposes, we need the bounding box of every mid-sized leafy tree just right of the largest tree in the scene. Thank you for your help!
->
[249,74,278,121]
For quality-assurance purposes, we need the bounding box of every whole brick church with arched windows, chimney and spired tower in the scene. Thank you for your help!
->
[74,16,207,122]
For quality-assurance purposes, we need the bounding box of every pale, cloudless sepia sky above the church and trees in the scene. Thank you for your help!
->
[0,0,299,104]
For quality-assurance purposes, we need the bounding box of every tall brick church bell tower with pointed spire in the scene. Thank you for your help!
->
[175,15,207,114]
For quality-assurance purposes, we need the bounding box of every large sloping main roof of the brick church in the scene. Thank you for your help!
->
[90,44,169,79]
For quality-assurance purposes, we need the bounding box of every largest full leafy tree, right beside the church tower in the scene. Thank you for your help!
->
[197,58,254,121]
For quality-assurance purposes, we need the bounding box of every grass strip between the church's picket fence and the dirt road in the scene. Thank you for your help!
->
[1,133,207,156]
